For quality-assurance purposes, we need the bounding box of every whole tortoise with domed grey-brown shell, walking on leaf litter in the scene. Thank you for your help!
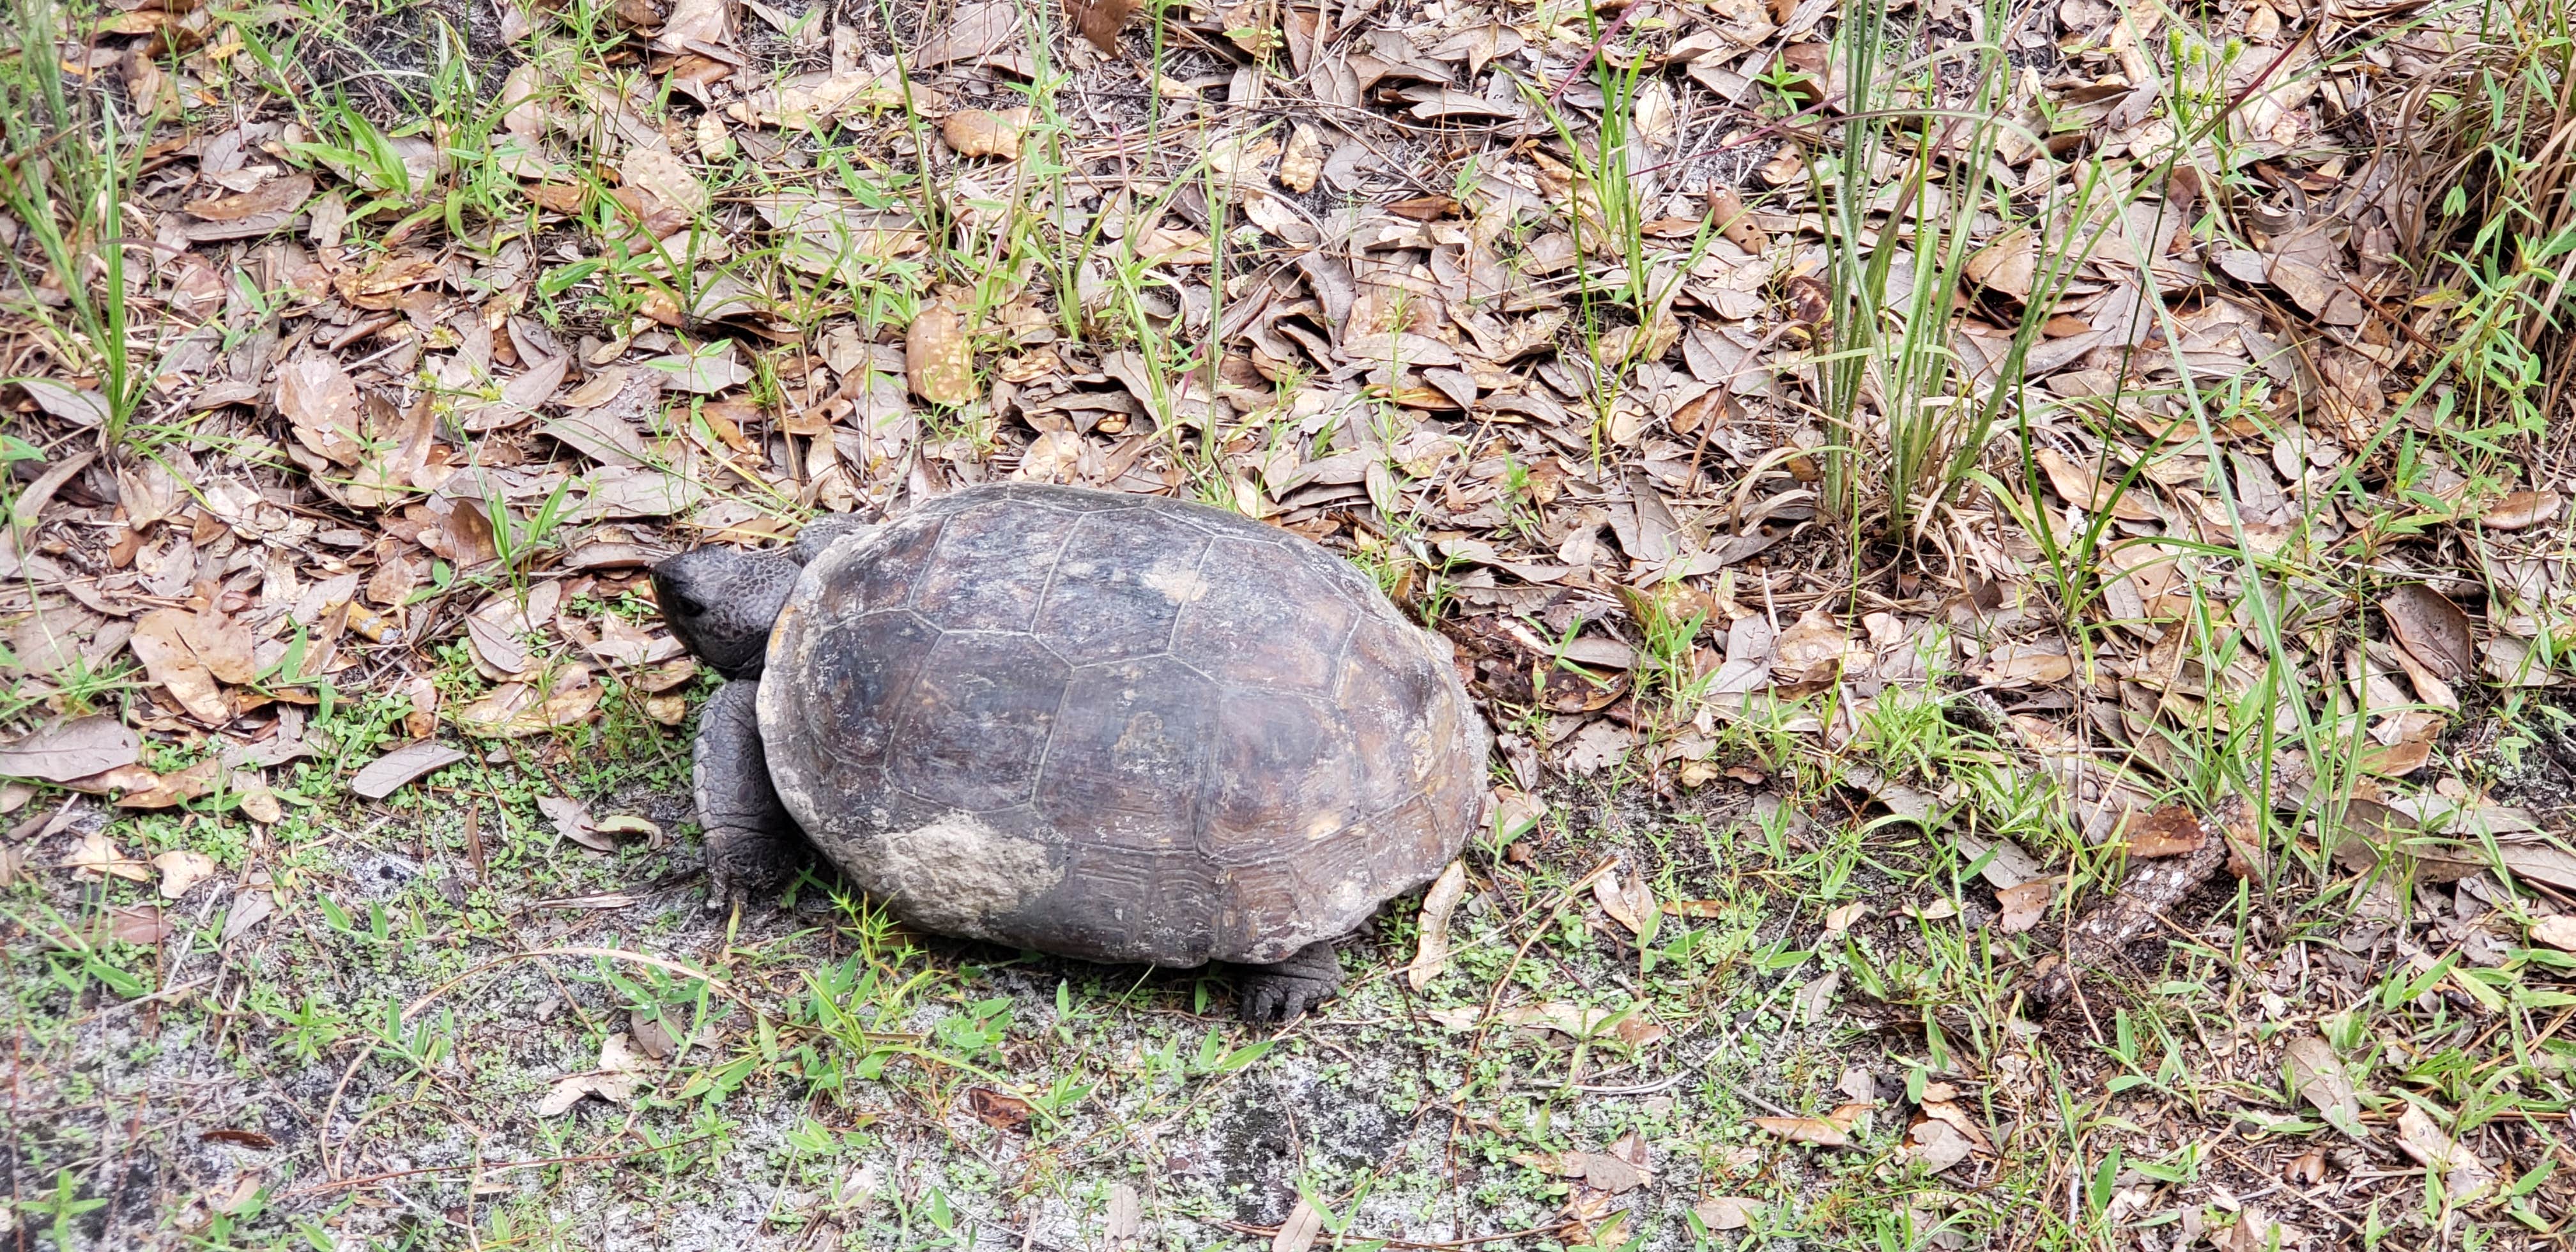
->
[652,482,1489,1020]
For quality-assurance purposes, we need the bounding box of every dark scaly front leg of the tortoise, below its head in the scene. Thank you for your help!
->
[691,678,804,910]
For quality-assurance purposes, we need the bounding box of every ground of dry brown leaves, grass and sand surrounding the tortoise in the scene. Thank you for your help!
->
[0,0,2576,1252]
